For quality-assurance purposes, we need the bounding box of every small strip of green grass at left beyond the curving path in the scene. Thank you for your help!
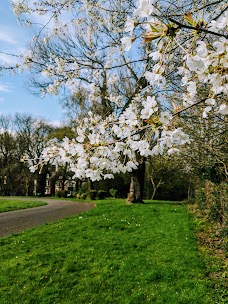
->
[0,198,47,213]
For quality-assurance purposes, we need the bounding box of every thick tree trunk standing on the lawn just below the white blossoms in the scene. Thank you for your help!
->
[127,160,145,204]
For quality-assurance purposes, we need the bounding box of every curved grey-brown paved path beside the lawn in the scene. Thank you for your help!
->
[0,198,95,237]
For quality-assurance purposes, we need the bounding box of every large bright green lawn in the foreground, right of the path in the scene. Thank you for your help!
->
[0,200,222,304]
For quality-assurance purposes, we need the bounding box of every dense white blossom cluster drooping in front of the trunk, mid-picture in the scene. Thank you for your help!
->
[30,108,190,181]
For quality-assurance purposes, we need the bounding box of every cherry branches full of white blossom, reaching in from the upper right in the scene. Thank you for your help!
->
[4,0,228,201]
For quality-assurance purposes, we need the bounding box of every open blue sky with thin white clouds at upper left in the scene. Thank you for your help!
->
[0,0,64,123]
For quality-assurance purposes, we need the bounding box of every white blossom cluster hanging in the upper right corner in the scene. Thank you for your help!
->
[123,0,228,118]
